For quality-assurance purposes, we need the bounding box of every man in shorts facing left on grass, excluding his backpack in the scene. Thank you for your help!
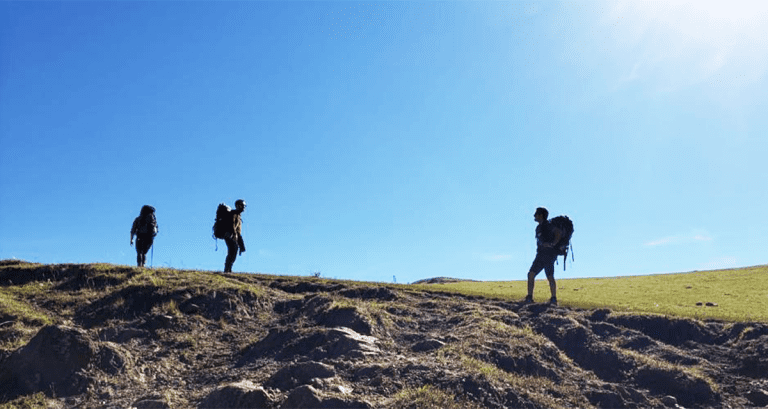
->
[525,207,563,305]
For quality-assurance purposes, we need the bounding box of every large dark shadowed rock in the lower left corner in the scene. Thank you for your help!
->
[0,325,97,398]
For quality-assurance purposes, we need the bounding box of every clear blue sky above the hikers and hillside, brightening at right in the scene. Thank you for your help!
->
[0,0,768,283]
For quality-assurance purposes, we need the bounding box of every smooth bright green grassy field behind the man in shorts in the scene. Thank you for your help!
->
[414,265,768,322]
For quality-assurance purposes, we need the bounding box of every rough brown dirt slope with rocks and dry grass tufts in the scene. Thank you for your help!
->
[0,261,768,408]
